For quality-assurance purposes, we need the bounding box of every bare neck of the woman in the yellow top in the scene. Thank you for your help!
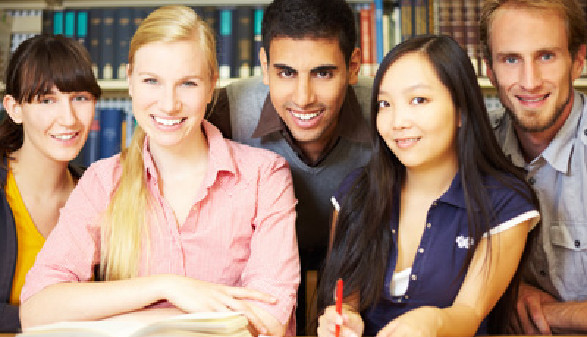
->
[10,146,73,194]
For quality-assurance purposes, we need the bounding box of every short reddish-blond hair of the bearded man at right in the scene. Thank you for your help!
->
[479,0,587,66]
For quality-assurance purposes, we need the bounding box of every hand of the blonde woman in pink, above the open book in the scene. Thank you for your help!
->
[162,275,277,334]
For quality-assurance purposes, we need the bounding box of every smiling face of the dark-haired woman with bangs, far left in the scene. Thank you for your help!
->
[4,86,96,162]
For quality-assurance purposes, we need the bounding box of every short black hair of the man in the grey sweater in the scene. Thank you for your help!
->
[261,0,357,66]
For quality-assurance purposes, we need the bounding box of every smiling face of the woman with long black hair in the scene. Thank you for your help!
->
[376,52,458,170]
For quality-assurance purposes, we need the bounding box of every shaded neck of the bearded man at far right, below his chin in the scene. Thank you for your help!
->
[514,95,574,162]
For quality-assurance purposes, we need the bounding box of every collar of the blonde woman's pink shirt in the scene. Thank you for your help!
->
[143,120,237,187]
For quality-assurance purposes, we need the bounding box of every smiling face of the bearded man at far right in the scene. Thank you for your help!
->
[488,6,584,132]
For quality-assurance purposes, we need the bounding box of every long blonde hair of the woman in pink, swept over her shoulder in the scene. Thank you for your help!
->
[100,6,218,280]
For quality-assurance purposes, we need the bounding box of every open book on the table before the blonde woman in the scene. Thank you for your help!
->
[17,312,251,337]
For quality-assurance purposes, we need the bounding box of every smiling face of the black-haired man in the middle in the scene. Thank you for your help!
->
[260,38,359,157]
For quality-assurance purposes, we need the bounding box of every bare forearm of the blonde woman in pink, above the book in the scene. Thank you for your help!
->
[20,275,164,329]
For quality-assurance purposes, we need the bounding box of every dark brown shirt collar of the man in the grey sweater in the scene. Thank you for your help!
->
[252,86,370,143]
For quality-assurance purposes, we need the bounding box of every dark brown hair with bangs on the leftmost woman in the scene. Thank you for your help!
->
[0,34,102,158]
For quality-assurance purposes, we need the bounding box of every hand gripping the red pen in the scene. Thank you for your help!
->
[318,304,364,337]
